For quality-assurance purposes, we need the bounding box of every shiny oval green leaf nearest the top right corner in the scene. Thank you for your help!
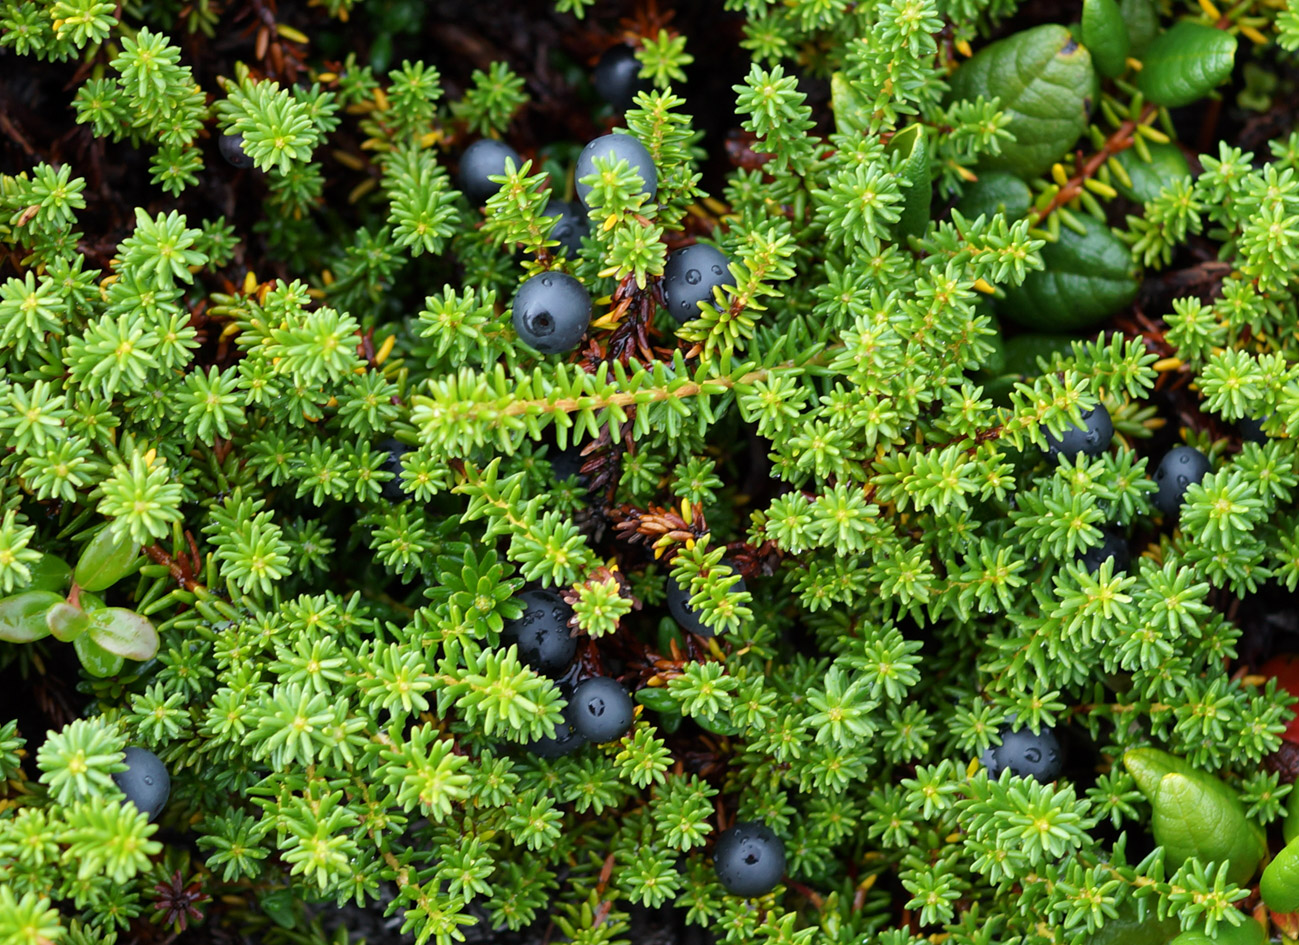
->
[1137,19,1237,108]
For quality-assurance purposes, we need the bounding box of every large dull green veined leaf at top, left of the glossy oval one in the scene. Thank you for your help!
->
[948,23,1098,178]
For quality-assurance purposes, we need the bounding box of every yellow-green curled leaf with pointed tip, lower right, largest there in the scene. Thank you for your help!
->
[1124,749,1268,885]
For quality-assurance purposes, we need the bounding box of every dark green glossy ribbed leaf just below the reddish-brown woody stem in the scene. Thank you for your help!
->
[998,216,1138,331]
